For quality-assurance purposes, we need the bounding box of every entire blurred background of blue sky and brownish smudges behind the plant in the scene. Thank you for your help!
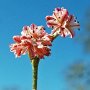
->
[0,0,90,90]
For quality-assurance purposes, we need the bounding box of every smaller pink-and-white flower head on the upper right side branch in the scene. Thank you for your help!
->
[46,8,80,38]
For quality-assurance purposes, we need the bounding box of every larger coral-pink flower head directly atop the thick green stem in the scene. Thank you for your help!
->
[10,24,52,59]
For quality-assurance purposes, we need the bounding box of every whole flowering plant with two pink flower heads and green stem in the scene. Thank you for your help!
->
[10,8,80,90]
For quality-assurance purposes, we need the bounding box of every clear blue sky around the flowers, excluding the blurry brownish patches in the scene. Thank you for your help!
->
[0,0,90,90]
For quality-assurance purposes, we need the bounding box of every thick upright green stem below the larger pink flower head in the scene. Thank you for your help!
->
[31,58,39,90]
